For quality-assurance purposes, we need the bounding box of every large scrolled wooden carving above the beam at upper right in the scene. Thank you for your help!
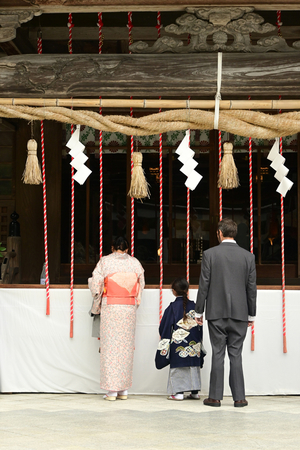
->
[130,7,300,53]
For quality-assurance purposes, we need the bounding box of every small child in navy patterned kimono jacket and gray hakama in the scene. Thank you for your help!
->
[156,278,205,400]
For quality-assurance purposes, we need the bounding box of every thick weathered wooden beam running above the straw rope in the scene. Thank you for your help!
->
[0,52,300,99]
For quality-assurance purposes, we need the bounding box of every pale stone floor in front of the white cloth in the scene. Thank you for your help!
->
[0,394,300,450]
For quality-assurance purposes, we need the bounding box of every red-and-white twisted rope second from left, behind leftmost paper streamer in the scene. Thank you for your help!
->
[68,13,75,338]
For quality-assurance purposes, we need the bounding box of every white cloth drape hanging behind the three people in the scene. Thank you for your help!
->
[0,288,300,395]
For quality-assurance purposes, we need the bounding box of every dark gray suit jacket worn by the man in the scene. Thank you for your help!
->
[195,242,257,321]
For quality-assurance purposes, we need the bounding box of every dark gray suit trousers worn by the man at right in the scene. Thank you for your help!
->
[208,319,248,401]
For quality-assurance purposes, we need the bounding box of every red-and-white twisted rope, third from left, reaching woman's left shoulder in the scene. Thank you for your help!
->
[98,13,103,258]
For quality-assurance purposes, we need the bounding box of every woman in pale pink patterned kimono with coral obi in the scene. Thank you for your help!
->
[89,237,145,400]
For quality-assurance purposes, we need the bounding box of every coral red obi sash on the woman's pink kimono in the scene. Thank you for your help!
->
[103,272,139,305]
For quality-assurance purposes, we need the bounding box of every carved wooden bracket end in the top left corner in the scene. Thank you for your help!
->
[0,9,42,42]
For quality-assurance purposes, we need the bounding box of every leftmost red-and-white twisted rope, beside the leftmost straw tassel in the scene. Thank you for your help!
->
[37,31,50,316]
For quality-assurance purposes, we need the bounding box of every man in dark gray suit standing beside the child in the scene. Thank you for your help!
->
[195,218,257,407]
